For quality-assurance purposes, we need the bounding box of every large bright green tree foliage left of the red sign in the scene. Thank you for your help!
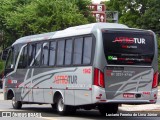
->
[0,0,94,46]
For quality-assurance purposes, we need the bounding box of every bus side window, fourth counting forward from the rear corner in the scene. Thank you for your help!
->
[57,40,65,65]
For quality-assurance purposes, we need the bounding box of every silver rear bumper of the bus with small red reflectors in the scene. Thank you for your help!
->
[92,86,158,104]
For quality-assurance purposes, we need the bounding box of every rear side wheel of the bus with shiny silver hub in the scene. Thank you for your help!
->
[57,96,70,115]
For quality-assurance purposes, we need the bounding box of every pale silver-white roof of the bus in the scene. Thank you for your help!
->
[13,23,128,45]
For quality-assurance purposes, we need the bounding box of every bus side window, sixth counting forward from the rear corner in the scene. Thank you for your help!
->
[42,42,49,66]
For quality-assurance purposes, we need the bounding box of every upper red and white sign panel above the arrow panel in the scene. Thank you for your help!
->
[89,4,106,12]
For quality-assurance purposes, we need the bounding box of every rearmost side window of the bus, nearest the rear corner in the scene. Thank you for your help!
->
[83,37,92,64]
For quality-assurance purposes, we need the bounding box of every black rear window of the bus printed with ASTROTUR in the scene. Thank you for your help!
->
[102,31,154,65]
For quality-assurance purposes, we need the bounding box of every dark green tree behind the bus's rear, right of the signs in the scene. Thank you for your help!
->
[106,0,160,32]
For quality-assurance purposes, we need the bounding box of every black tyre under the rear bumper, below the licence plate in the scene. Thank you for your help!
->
[98,104,118,116]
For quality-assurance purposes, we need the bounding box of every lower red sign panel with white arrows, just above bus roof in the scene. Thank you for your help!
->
[92,11,106,22]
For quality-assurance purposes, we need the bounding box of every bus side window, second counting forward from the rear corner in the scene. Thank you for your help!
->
[73,38,83,65]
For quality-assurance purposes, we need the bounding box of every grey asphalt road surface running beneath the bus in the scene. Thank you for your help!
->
[0,100,160,120]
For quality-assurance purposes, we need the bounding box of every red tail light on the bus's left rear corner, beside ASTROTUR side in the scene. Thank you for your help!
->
[94,68,105,88]
